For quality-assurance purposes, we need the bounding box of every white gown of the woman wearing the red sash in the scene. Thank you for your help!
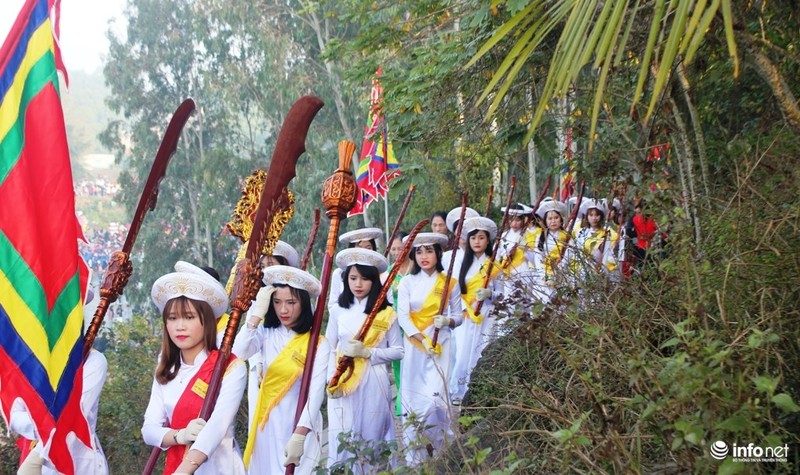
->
[142,350,247,475]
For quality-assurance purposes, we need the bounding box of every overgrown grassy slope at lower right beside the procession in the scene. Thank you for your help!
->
[465,128,800,473]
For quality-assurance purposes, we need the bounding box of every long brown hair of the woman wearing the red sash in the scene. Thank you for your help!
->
[156,296,217,384]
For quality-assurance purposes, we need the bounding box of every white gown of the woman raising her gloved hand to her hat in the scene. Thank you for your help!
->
[233,325,330,475]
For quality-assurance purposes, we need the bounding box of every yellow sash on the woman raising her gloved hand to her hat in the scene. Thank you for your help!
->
[244,332,322,467]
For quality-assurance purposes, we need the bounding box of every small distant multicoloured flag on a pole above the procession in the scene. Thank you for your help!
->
[348,68,400,216]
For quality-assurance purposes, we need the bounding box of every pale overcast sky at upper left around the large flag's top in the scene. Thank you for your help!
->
[0,0,126,73]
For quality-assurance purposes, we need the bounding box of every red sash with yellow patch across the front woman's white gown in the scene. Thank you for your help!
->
[164,350,236,474]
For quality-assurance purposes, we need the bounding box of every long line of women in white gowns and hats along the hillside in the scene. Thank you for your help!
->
[10,167,657,474]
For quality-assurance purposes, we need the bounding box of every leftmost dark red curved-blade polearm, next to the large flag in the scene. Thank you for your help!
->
[83,99,195,361]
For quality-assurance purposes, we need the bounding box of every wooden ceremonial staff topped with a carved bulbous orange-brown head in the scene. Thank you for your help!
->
[286,140,358,475]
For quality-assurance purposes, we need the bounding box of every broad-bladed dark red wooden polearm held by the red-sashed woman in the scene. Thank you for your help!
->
[142,96,323,475]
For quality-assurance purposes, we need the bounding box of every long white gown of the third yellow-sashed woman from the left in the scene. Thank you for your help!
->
[397,270,462,465]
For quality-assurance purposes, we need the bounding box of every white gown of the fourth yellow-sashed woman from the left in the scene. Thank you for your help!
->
[450,253,503,400]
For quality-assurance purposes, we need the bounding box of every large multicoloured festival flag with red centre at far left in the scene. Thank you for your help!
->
[0,0,91,474]
